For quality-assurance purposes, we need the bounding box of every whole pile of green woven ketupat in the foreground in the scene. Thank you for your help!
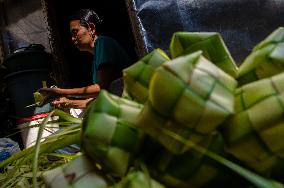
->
[39,28,284,188]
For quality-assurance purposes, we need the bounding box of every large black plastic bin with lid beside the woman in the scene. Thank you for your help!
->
[2,44,54,118]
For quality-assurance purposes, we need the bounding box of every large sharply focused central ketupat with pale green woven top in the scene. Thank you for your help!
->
[152,52,237,131]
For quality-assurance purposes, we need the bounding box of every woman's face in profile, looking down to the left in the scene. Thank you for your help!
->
[70,20,94,51]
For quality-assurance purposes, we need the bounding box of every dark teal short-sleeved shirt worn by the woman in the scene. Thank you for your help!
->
[92,36,130,83]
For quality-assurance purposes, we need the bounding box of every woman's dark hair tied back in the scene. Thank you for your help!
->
[69,9,103,28]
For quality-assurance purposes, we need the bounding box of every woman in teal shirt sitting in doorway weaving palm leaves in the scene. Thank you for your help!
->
[39,9,130,108]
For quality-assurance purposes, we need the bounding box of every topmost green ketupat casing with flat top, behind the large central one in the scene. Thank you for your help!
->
[170,32,238,78]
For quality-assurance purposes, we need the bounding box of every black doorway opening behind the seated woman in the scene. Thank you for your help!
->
[48,0,137,87]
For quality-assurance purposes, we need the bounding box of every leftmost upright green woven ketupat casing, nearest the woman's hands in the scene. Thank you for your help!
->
[82,90,142,176]
